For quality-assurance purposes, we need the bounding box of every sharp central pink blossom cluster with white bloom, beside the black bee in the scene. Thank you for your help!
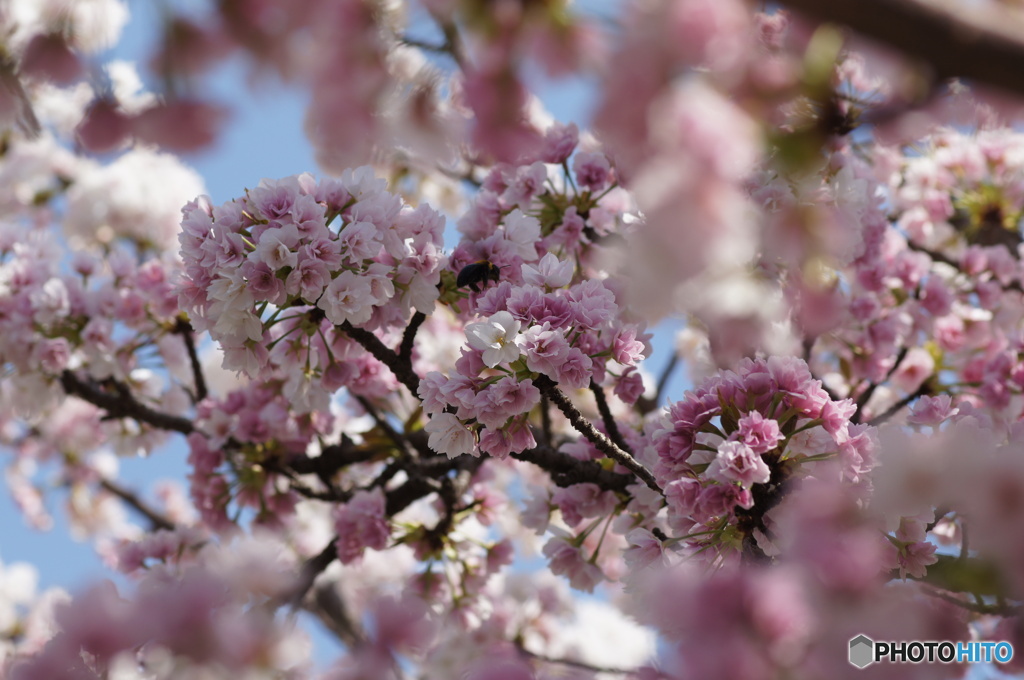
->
[419,141,649,458]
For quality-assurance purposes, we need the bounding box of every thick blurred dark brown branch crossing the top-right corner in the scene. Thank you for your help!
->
[784,0,1024,94]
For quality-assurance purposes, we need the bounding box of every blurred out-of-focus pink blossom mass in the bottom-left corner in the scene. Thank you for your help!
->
[10,546,309,680]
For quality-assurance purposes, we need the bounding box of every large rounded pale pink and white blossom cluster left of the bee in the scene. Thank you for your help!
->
[179,168,445,411]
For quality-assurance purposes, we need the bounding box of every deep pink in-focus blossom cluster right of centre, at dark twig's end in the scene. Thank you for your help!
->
[649,357,876,559]
